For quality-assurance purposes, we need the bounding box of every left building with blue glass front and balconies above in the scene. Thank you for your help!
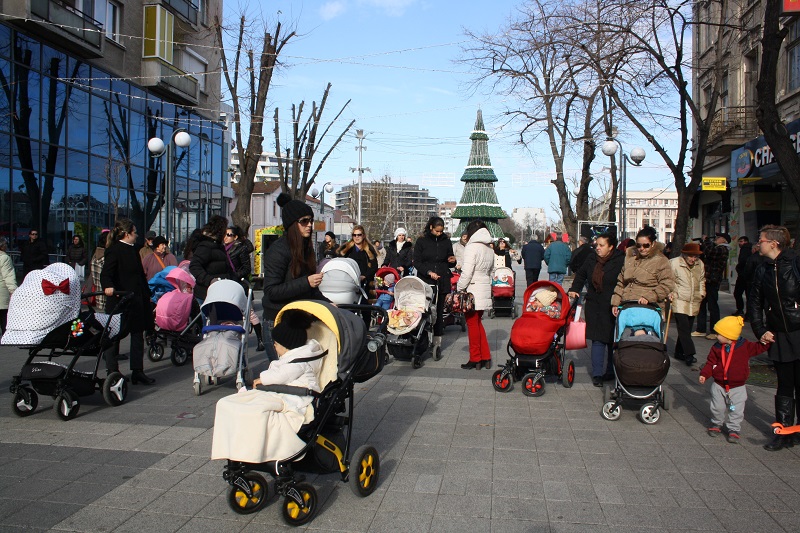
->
[0,0,229,254]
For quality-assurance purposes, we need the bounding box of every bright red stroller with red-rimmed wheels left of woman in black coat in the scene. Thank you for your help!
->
[492,281,575,396]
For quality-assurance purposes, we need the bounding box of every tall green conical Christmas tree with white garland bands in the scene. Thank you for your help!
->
[452,109,508,238]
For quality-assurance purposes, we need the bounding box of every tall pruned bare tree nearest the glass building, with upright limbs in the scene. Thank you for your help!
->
[214,15,295,234]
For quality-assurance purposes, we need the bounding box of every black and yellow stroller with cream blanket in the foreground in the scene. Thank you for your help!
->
[211,301,386,526]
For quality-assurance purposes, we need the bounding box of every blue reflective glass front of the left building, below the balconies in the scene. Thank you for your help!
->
[0,24,229,255]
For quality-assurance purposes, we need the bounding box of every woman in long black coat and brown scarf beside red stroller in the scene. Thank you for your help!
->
[569,233,625,387]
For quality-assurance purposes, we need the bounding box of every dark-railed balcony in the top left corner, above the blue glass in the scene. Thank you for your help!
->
[19,0,105,58]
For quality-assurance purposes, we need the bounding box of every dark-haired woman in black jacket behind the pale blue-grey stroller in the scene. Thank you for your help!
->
[189,215,235,306]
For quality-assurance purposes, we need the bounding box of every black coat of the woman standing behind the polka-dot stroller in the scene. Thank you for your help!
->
[100,241,154,333]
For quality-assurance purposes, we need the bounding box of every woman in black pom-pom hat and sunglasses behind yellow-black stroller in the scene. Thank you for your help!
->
[261,193,327,362]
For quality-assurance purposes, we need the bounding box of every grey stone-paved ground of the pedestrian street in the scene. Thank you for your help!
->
[0,264,800,533]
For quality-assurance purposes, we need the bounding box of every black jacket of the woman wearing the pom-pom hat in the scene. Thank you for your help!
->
[261,236,327,320]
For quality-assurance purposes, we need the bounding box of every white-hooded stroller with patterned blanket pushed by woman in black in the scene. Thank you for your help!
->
[386,276,434,368]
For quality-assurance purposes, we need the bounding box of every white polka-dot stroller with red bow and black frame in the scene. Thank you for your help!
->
[0,263,134,421]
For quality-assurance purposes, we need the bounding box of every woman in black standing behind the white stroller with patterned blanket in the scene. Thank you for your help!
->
[414,216,456,356]
